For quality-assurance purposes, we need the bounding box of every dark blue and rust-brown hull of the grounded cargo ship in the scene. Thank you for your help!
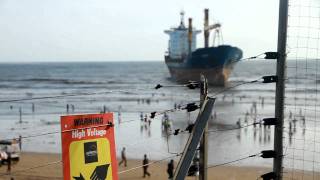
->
[165,45,242,86]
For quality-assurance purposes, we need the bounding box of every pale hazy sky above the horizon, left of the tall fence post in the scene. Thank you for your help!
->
[0,0,278,62]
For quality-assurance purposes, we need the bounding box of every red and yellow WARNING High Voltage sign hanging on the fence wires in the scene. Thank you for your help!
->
[61,113,118,180]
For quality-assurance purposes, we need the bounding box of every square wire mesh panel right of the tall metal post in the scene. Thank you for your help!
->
[283,0,320,179]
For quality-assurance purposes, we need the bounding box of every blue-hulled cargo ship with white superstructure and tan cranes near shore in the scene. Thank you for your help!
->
[164,9,242,86]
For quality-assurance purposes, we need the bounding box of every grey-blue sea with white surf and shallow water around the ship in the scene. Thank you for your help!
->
[0,60,318,170]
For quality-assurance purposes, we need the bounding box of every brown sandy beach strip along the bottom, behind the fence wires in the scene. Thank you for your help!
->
[0,153,320,180]
